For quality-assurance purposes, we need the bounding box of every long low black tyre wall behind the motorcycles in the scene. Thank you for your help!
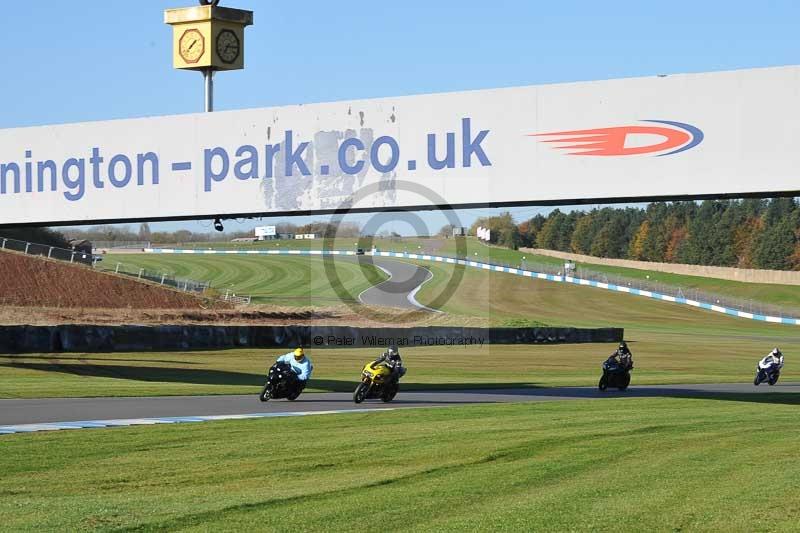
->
[0,325,624,353]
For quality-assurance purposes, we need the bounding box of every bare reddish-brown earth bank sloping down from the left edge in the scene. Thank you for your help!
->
[0,251,219,310]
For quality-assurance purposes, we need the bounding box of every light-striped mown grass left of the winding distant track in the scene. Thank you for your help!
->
[102,254,388,306]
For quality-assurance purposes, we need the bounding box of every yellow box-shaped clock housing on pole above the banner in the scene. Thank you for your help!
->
[164,5,253,70]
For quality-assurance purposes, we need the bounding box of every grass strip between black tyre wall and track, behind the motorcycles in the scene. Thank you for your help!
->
[0,332,800,398]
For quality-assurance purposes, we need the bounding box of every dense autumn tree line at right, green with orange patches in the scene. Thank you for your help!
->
[470,198,800,270]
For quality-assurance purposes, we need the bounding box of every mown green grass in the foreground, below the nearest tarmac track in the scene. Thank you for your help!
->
[0,395,800,532]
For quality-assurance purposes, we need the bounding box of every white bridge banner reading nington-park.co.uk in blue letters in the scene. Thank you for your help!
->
[0,66,800,225]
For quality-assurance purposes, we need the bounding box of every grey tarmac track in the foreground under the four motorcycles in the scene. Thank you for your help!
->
[0,383,800,426]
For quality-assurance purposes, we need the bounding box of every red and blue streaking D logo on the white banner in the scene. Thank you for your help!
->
[531,120,704,157]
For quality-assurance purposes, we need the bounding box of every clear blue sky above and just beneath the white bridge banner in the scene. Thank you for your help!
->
[0,0,800,232]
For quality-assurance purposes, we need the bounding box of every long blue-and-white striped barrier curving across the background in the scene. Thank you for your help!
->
[145,248,800,326]
